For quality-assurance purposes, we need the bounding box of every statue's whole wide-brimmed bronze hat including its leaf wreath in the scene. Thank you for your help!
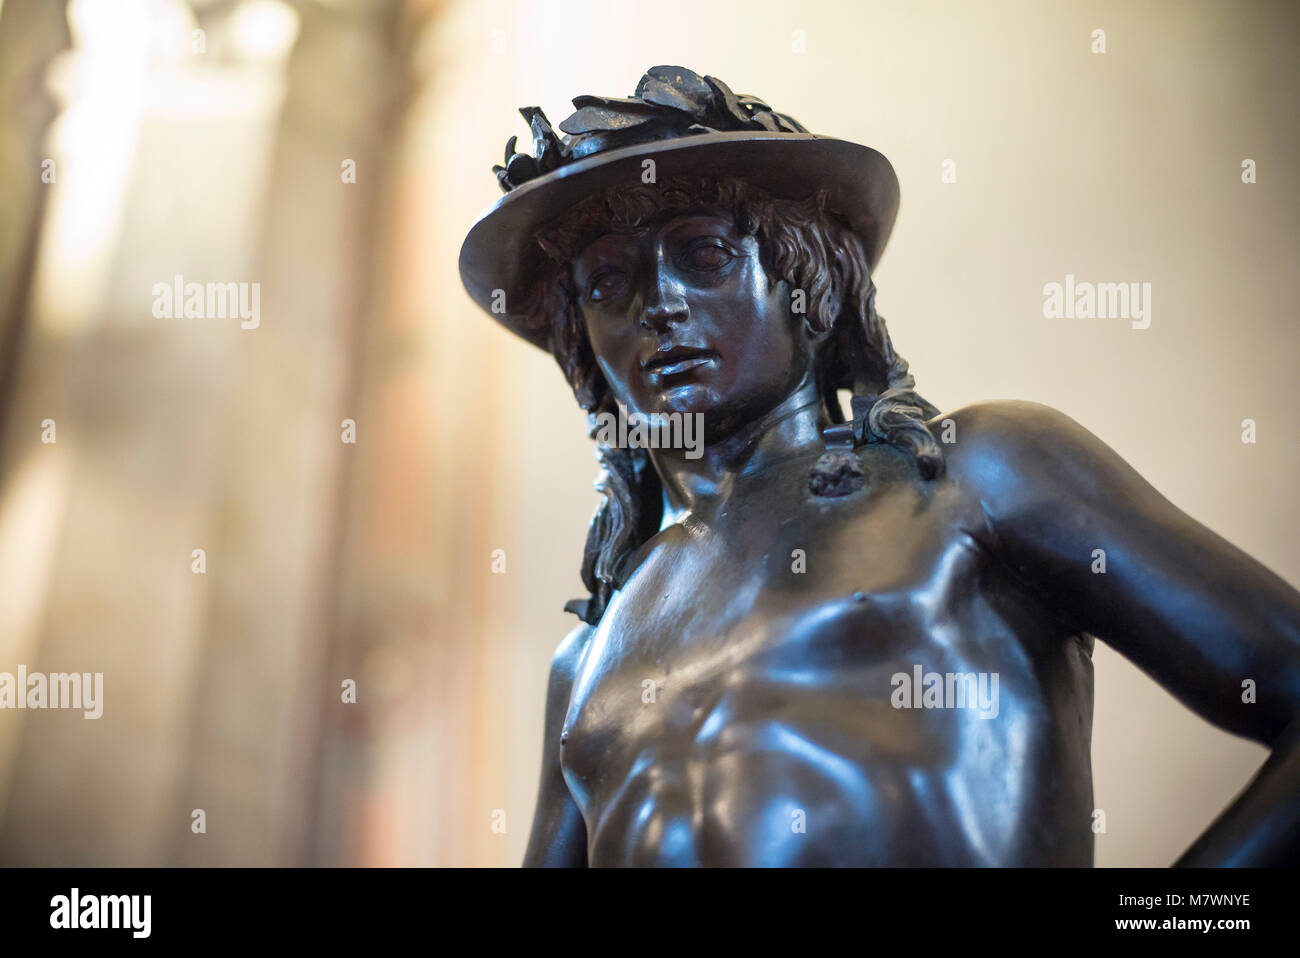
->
[460,66,898,350]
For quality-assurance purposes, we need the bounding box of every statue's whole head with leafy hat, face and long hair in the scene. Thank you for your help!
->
[460,66,943,623]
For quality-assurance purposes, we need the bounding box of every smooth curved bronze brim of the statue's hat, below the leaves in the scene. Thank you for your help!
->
[460,133,898,350]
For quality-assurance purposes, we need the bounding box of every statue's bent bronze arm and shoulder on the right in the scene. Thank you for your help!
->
[950,403,1300,866]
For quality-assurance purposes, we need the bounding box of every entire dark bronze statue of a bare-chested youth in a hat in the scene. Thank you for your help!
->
[462,66,1300,866]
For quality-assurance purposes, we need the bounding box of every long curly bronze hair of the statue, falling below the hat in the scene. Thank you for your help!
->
[528,175,944,625]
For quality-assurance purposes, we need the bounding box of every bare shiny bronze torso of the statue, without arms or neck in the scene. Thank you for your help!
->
[560,446,1092,866]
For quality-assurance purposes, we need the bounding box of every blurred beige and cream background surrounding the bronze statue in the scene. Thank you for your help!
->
[0,0,1300,866]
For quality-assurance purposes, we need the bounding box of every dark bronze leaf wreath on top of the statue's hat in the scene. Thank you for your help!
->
[493,66,807,192]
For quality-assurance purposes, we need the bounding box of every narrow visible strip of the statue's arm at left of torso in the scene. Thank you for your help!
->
[524,625,592,868]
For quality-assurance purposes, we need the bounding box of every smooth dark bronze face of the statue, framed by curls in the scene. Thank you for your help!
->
[573,211,813,439]
